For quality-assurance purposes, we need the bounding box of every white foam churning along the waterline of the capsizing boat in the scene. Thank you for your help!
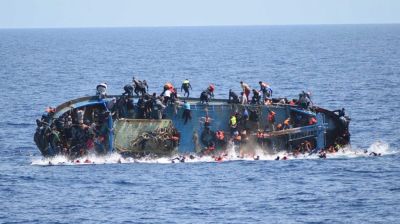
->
[32,141,399,166]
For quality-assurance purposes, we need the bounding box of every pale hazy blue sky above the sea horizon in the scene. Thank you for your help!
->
[0,0,400,28]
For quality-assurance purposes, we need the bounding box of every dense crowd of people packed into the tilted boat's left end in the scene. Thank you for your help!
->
[35,104,111,157]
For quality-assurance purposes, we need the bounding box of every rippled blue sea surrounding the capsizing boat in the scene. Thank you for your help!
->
[0,25,400,223]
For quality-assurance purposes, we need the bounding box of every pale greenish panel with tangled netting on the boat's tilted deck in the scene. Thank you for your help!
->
[114,119,179,154]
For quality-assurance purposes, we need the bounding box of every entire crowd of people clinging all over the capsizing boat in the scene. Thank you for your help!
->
[37,77,350,159]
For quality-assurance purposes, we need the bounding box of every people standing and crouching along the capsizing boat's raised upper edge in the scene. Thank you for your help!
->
[96,77,313,125]
